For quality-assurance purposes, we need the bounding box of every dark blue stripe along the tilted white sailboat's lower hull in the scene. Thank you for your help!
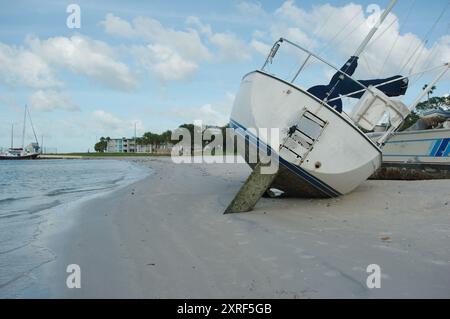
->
[230,119,342,197]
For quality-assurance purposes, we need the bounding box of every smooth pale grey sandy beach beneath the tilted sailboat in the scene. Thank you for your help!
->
[23,158,450,298]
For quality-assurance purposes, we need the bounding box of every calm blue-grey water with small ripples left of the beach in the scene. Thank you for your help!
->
[0,160,149,297]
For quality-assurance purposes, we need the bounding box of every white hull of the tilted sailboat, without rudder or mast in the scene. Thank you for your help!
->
[230,71,381,197]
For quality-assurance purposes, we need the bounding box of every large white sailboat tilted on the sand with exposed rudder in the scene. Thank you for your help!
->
[225,0,450,213]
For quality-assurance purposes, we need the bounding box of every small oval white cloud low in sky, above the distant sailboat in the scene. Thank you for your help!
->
[29,90,80,112]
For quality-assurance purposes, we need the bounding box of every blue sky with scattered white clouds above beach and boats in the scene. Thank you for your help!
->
[0,0,450,152]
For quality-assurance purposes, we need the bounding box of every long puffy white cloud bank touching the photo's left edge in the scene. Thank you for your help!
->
[0,35,137,90]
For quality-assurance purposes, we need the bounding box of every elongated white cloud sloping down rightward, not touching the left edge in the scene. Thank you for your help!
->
[27,35,137,90]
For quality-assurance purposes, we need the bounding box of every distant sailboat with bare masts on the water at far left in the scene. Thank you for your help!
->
[0,105,40,160]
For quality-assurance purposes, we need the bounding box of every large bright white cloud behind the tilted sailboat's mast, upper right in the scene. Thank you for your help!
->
[248,0,450,77]
